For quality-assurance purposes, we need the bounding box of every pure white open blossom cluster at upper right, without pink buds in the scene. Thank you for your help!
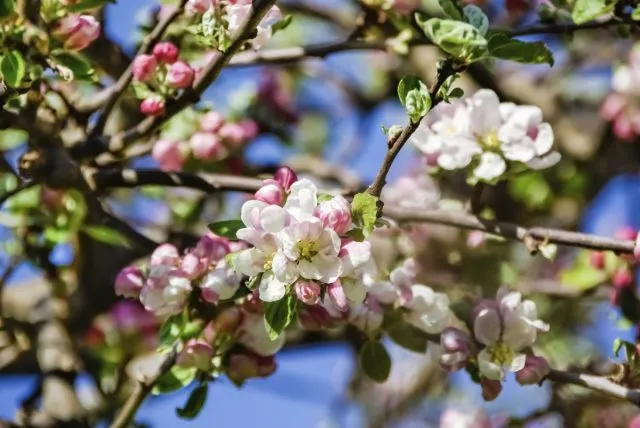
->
[411,89,560,183]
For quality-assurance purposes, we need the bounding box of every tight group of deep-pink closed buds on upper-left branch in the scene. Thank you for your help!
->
[133,42,196,116]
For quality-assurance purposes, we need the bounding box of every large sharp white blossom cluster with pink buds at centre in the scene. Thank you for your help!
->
[233,168,370,312]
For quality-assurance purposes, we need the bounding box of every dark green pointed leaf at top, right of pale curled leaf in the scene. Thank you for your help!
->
[489,33,554,67]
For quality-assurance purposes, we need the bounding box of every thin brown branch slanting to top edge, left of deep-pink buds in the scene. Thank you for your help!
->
[89,0,187,139]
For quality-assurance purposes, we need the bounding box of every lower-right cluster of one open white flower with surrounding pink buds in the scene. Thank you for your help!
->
[440,288,549,401]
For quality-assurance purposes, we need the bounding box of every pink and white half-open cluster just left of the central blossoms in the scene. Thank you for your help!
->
[115,235,242,316]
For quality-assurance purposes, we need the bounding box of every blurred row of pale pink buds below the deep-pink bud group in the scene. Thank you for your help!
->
[151,111,259,171]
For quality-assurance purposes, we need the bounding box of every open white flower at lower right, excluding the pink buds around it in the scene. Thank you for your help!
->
[473,288,549,380]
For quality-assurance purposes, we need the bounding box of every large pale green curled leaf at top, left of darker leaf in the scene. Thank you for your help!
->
[416,15,488,63]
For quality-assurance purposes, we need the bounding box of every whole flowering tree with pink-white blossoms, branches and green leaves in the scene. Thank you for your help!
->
[0,0,640,427]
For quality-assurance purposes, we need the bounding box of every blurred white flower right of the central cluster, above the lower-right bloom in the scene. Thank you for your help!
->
[405,284,451,334]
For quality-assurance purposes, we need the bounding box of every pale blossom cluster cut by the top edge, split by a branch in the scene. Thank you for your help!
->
[186,0,282,51]
